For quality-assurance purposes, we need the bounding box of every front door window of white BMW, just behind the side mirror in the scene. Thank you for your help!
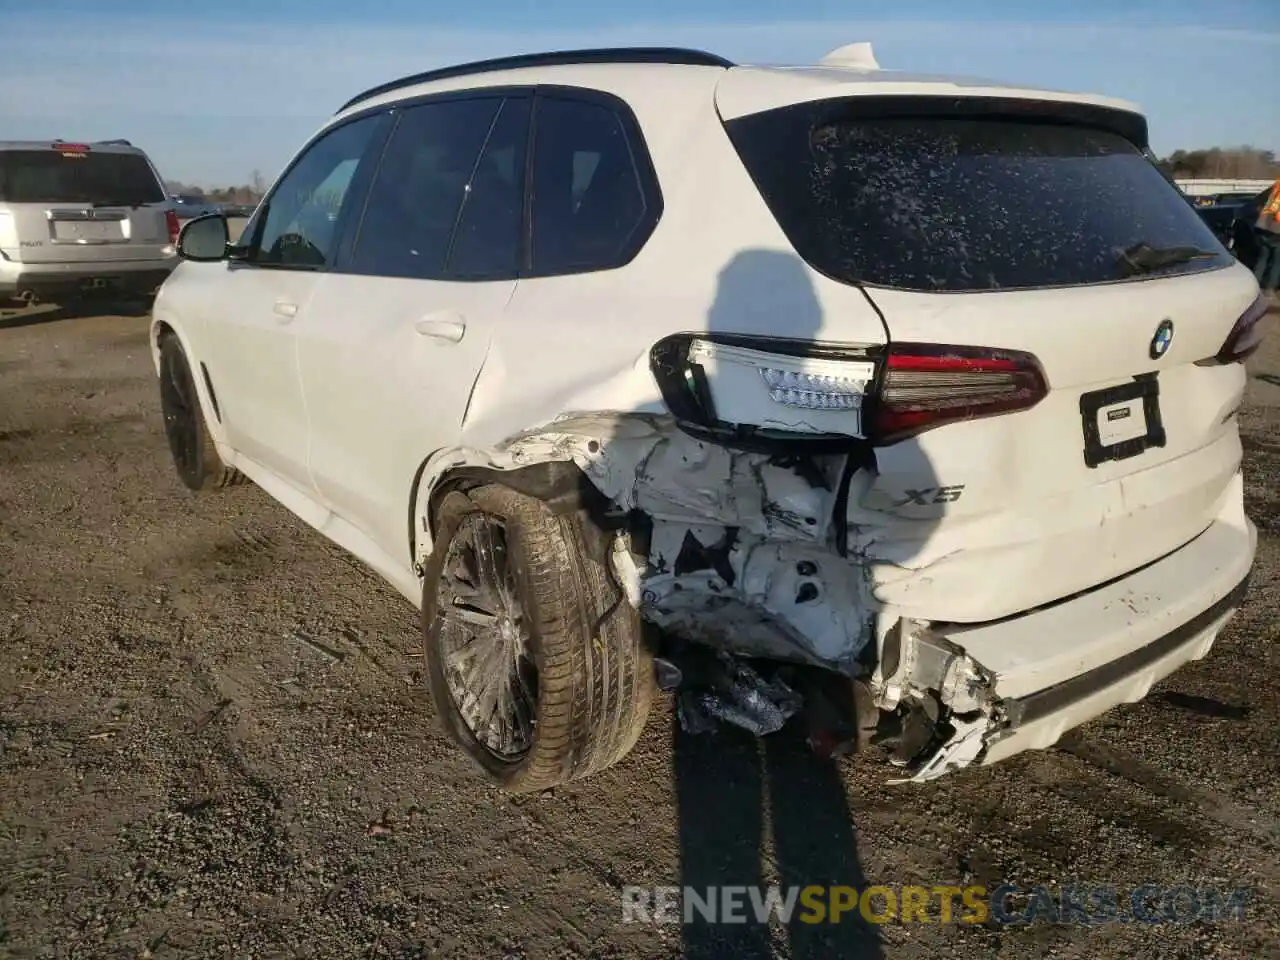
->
[252,115,381,268]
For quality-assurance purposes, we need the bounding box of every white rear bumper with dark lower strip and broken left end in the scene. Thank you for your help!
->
[897,477,1257,781]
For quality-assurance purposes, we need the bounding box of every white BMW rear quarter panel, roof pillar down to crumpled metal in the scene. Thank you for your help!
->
[415,90,887,701]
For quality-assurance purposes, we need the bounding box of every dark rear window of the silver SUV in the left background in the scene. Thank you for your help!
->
[0,150,165,206]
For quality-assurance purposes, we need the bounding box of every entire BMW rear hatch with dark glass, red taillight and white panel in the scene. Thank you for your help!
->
[726,84,1260,622]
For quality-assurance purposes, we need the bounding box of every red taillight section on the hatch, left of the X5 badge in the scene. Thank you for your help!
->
[870,343,1048,444]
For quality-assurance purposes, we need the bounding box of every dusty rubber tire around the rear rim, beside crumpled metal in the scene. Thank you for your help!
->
[422,485,654,792]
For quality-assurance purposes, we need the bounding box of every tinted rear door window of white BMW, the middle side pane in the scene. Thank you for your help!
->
[351,97,503,279]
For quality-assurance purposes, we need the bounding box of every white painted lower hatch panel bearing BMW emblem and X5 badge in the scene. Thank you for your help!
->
[849,265,1256,622]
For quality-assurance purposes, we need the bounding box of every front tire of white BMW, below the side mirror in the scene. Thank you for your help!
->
[160,334,244,493]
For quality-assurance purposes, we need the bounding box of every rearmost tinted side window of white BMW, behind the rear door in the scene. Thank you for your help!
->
[532,97,654,274]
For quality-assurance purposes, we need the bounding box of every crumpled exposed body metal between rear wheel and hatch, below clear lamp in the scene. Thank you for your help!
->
[494,413,872,673]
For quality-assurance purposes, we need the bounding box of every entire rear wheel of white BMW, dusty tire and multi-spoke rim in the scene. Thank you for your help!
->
[422,485,654,792]
